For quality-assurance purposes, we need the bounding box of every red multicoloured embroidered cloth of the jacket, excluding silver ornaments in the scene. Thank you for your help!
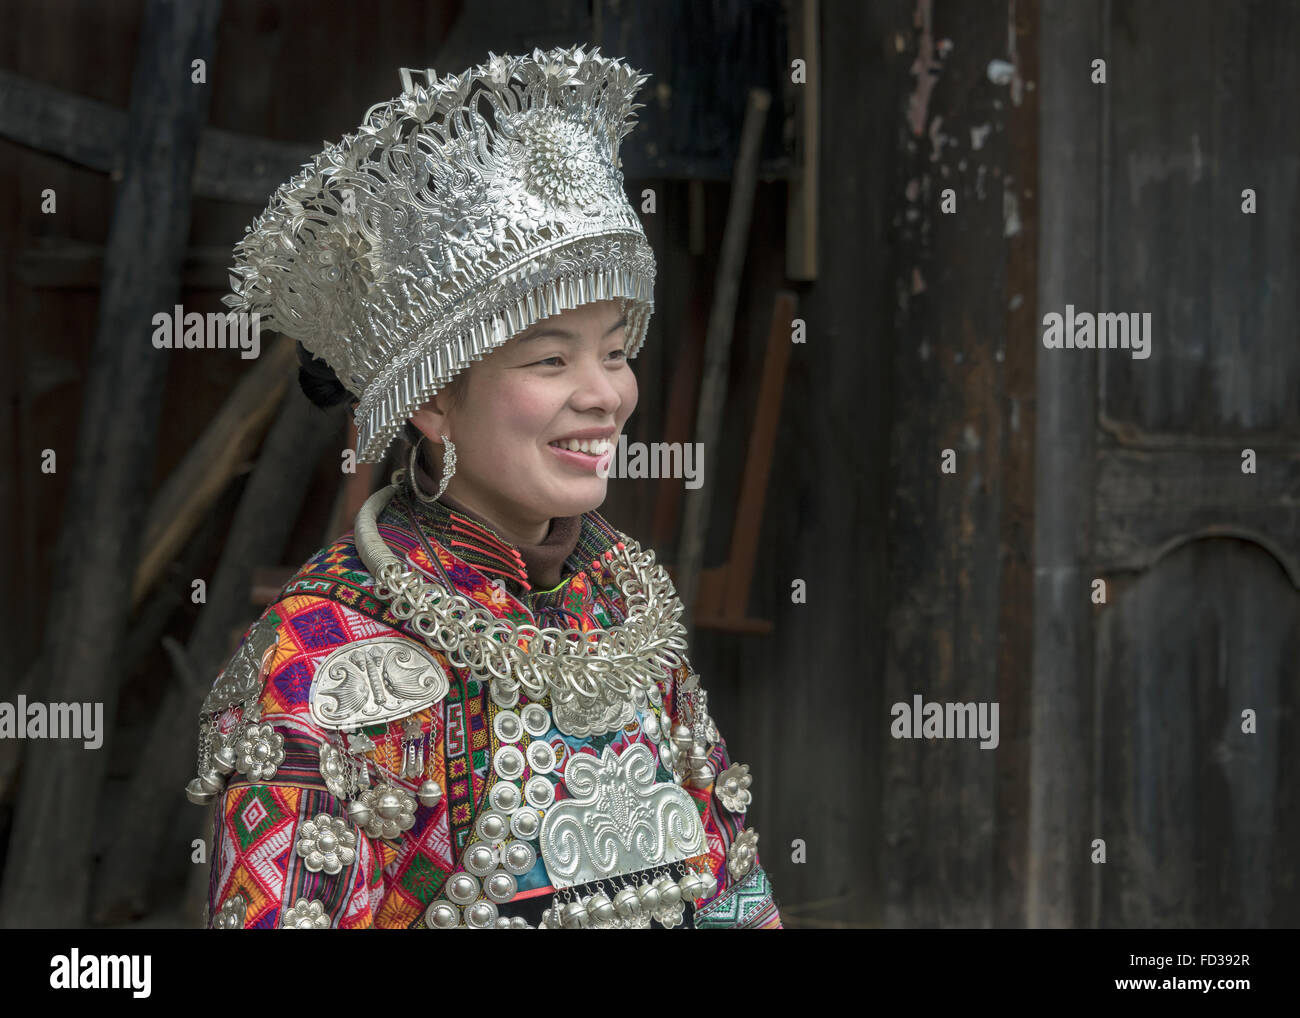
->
[197,497,780,928]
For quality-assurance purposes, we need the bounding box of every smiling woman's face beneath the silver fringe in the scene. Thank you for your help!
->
[411,300,637,543]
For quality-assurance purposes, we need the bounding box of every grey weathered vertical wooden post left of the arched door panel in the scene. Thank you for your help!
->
[1024,0,1102,927]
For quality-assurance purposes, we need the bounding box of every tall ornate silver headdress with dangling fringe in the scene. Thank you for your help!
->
[224,47,655,463]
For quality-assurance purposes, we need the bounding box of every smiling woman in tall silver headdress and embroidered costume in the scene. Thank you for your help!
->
[187,47,780,928]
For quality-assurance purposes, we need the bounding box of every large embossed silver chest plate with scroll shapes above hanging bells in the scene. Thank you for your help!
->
[538,742,705,888]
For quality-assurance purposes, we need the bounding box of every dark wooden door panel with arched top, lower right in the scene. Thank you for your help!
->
[1095,540,1300,928]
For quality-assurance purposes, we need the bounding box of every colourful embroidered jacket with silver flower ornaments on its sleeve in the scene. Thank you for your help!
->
[197,495,781,928]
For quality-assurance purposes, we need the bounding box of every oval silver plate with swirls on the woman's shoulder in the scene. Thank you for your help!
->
[311,636,451,729]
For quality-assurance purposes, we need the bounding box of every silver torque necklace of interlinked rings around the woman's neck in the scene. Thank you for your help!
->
[354,485,686,703]
